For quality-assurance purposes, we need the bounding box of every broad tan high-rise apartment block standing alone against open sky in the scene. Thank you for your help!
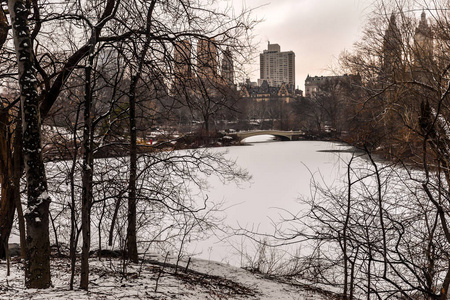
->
[258,42,295,89]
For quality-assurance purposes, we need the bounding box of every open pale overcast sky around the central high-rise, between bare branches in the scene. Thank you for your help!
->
[237,0,372,89]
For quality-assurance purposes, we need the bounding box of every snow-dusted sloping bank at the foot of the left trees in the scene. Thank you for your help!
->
[0,256,330,300]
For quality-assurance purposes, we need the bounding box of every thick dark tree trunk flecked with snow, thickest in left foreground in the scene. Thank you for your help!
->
[8,0,51,288]
